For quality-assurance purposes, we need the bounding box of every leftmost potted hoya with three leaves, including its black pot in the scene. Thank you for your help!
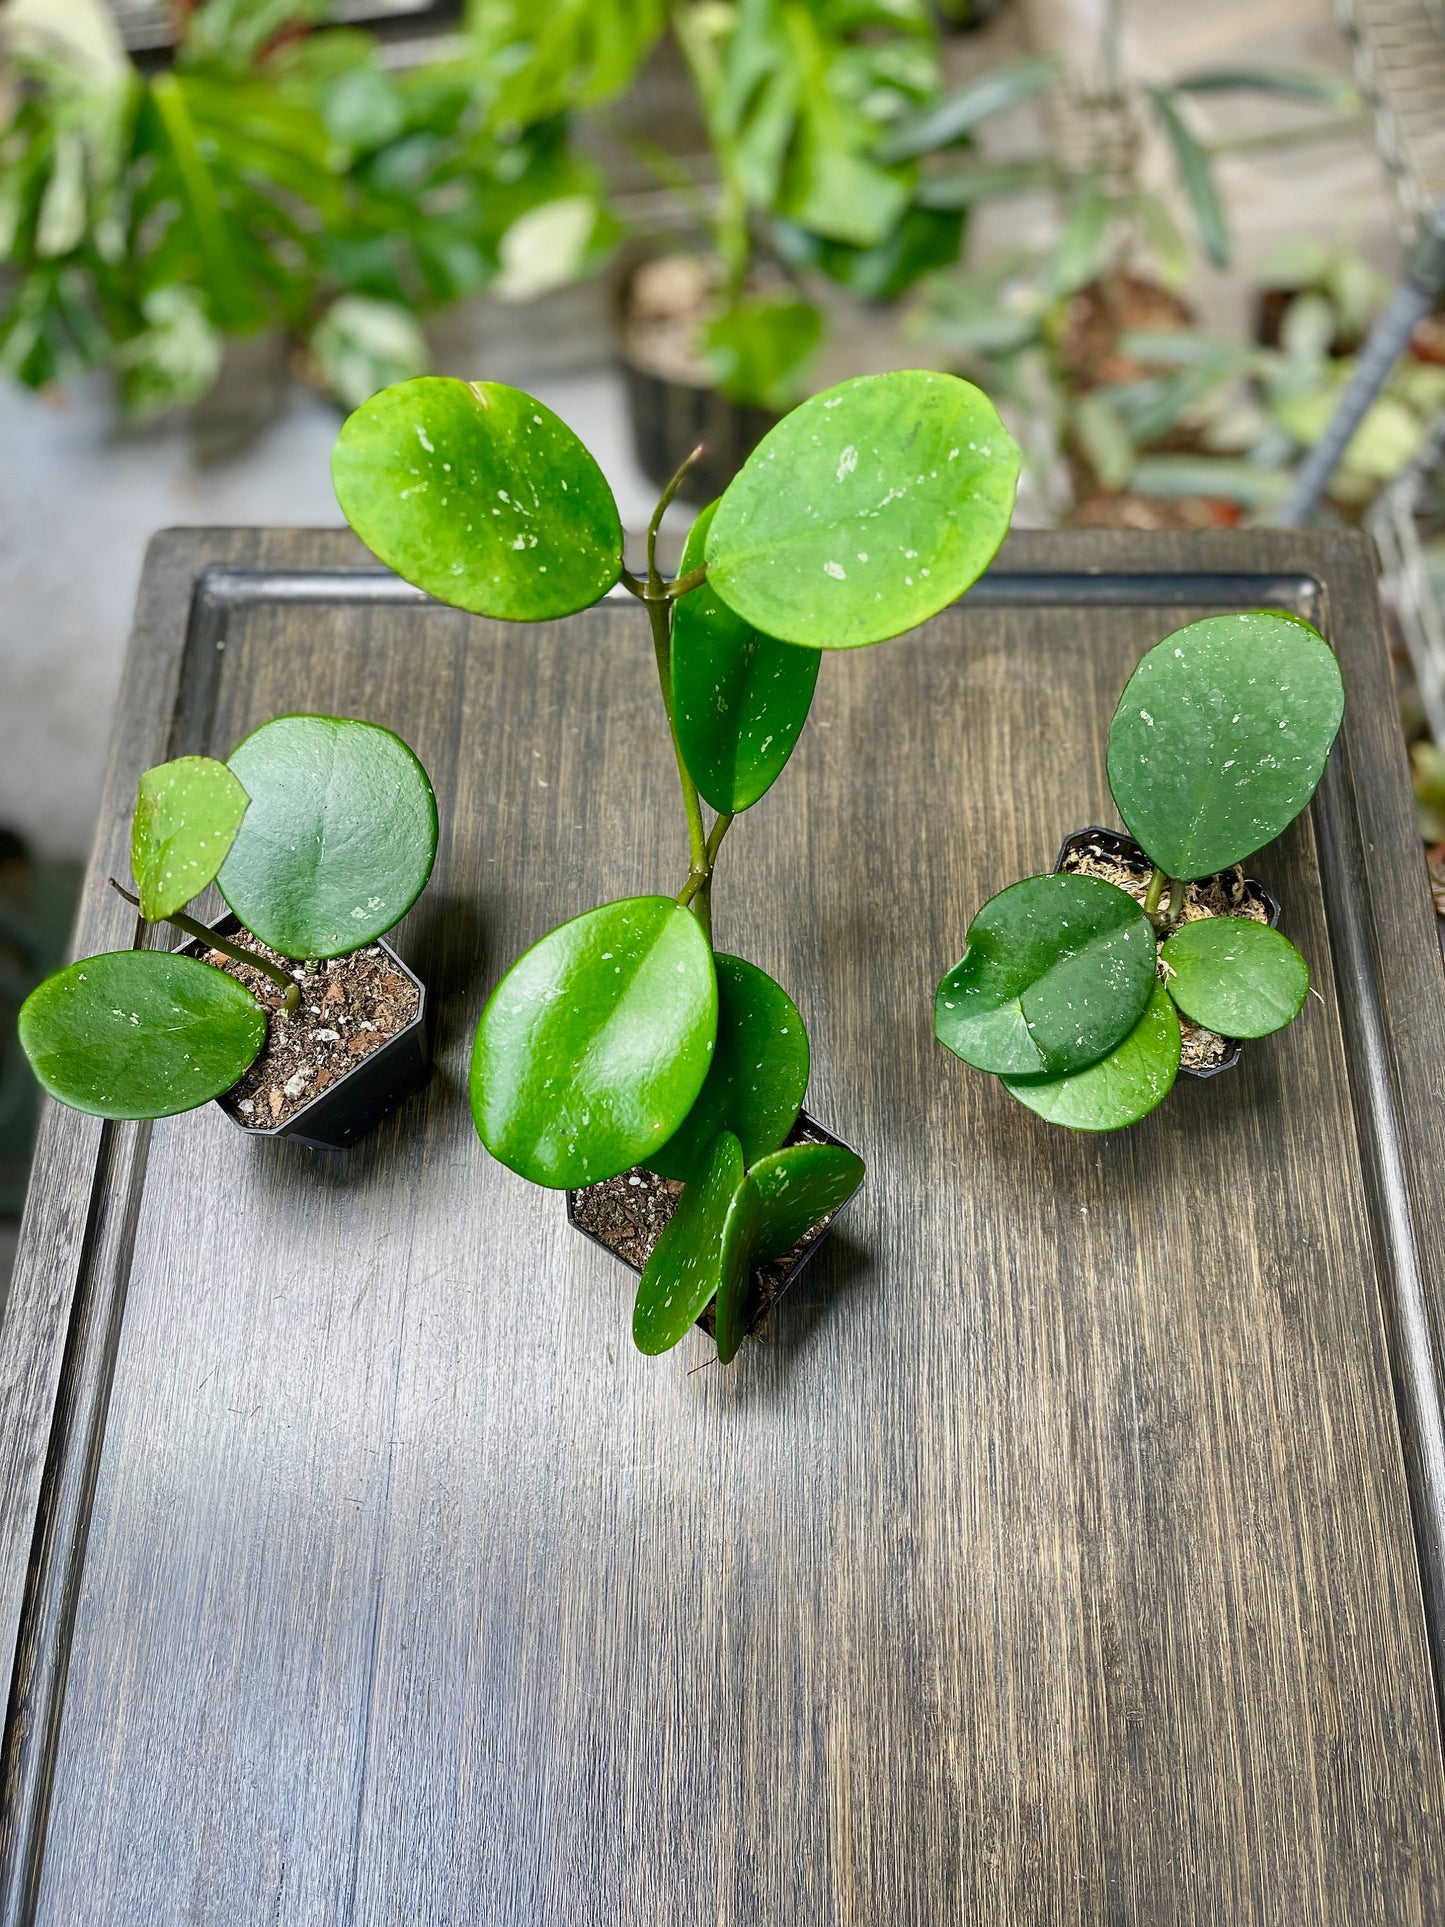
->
[19,715,437,1150]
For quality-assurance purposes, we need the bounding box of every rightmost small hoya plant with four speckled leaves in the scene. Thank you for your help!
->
[934,611,1345,1131]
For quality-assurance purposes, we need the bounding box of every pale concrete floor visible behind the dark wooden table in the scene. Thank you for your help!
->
[0,0,1399,856]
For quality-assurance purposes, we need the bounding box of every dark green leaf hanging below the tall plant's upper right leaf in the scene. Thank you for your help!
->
[672,503,823,815]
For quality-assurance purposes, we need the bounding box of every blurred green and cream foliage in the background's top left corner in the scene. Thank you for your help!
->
[0,0,632,414]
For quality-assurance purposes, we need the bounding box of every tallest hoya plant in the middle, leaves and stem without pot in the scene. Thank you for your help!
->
[331,372,1017,1360]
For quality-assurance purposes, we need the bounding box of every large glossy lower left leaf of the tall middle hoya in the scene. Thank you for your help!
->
[472,896,717,1189]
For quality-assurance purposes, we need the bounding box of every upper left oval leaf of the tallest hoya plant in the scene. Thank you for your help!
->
[331,376,622,622]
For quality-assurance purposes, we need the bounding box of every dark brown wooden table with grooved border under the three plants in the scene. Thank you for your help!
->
[0,532,1445,1927]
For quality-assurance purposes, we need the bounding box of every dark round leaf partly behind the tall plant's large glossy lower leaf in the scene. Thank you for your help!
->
[647,952,807,1183]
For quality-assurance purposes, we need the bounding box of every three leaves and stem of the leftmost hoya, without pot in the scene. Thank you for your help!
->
[19,715,437,1118]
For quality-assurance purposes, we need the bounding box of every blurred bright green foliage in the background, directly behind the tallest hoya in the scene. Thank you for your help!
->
[661,0,1056,412]
